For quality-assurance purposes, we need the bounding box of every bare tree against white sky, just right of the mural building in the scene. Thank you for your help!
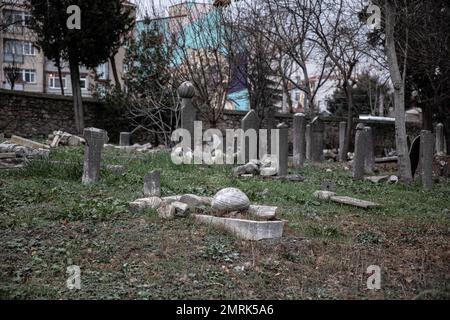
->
[264,0,334,116]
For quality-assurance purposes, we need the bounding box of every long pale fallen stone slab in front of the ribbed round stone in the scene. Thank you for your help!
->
[194,215,285,241]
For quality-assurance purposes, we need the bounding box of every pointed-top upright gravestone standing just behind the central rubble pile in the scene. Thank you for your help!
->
[241,110,259,163]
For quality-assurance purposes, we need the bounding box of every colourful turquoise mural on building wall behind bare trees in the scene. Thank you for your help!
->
[136,2,249,111]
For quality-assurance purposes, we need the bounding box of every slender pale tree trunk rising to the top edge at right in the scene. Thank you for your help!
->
[385,1,412,182]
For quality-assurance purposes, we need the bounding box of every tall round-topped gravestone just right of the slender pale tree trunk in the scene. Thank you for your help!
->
[420,130,435,190]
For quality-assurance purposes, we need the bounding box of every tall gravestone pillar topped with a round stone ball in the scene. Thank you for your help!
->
[178,81,197,151]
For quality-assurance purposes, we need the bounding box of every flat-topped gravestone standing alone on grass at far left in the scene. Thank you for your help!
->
[82,128,108,185]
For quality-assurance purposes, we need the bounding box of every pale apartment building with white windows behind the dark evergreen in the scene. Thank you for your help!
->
[0,0,132,97]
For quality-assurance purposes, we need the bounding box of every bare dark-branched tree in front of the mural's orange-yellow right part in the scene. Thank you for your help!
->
[225,1,284,120]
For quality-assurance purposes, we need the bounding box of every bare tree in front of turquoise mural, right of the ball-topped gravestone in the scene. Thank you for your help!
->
[164,3,231,127]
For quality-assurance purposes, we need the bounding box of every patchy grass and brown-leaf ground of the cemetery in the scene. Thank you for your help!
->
[0,147,450,299]
